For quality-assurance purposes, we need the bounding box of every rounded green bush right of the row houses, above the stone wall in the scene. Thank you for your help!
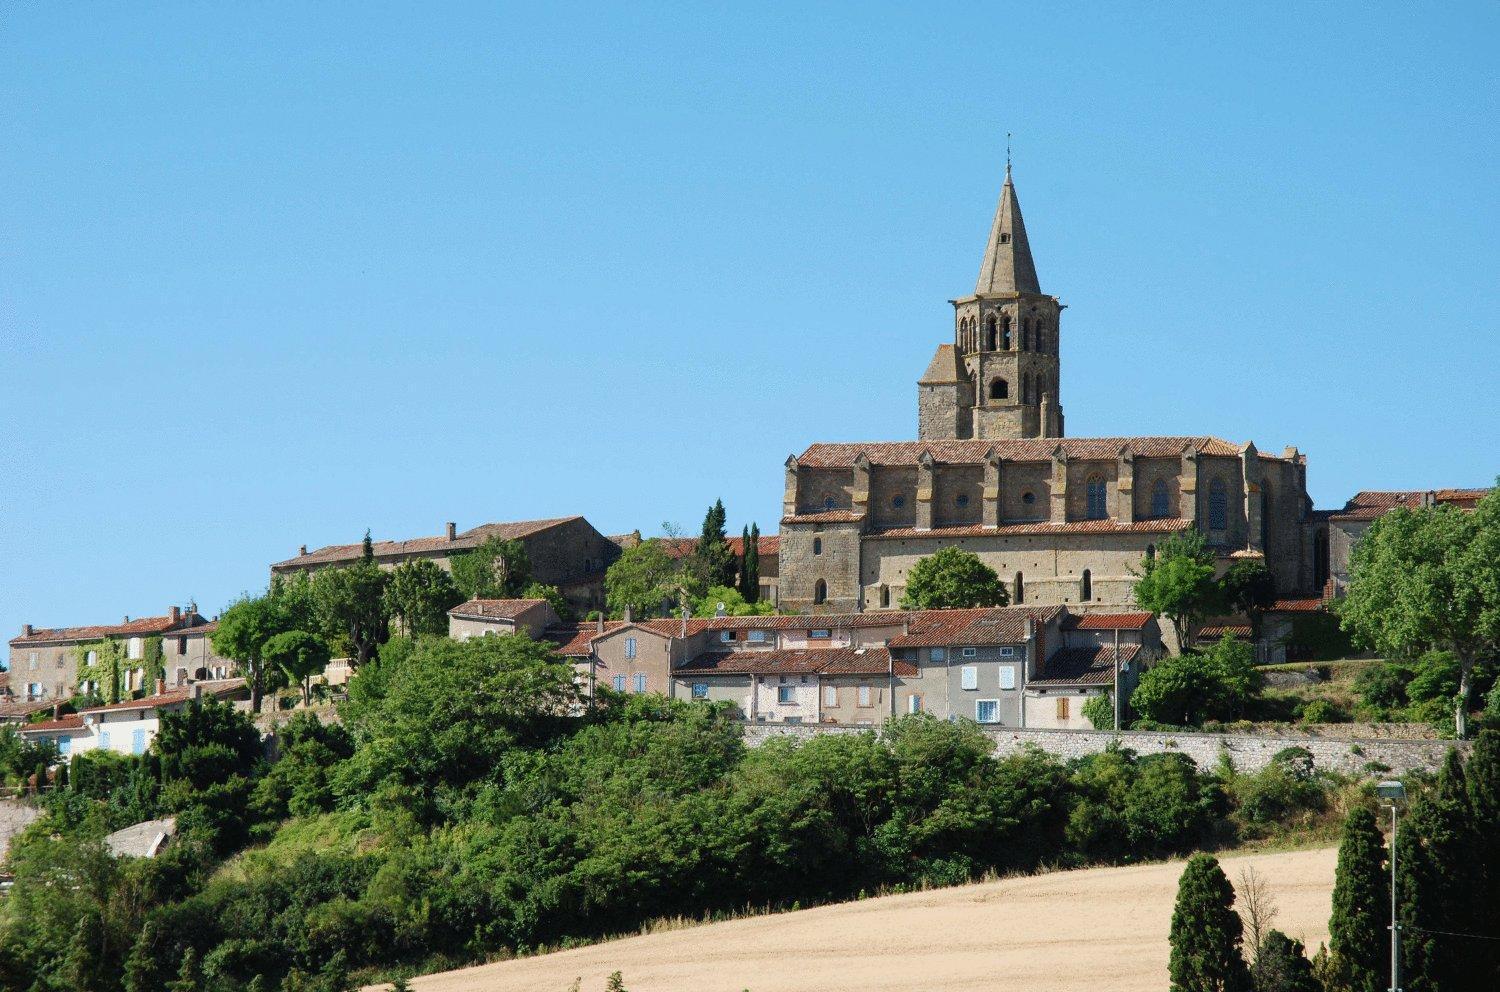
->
[1130,636,1260,726]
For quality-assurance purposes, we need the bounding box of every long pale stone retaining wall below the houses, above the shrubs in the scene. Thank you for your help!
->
[744,723,1470,776]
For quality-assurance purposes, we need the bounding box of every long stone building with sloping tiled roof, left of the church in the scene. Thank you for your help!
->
[272,516,620,614]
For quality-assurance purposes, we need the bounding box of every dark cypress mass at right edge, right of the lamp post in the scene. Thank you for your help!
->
[1397,750,1493,992]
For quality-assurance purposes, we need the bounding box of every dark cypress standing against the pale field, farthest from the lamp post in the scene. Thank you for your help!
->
[1169,854,1251,992]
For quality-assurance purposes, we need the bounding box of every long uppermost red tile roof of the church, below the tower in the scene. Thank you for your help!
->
[797,437,1254,468]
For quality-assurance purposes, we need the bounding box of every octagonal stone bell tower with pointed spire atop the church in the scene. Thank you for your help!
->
[917,162,1064,440]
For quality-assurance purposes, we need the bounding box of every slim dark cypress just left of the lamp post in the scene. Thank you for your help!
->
[1328,807,1391,992]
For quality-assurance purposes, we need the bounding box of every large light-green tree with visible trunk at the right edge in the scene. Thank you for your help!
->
[1338,489,1500,737]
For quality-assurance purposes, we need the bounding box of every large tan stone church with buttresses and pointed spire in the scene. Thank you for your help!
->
[780,167,1326,627]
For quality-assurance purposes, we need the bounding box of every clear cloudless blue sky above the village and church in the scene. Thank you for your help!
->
[0,3,1500,630]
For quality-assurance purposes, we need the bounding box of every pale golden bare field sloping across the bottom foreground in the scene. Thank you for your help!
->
[384,848,1337,992]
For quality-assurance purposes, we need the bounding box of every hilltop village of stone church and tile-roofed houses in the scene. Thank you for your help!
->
[0,167,1487,755]
